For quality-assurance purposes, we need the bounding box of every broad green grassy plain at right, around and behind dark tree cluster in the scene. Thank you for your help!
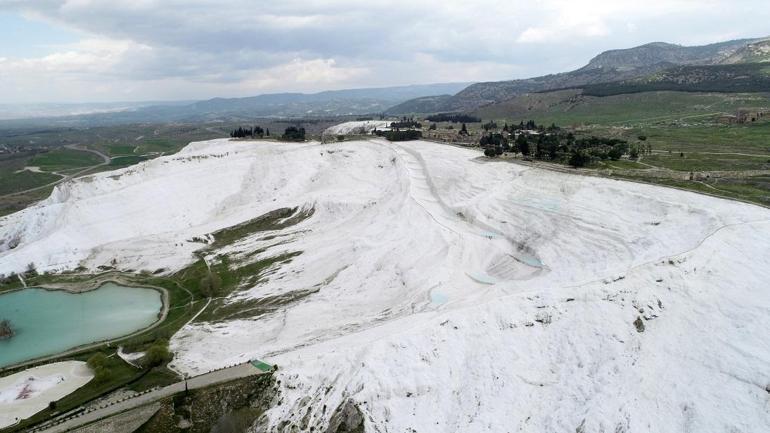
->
[462,90,770,205]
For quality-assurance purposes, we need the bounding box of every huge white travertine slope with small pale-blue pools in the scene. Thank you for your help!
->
[0,140,770,433]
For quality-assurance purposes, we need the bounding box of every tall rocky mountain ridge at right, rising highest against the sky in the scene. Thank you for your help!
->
[390,39,762,112]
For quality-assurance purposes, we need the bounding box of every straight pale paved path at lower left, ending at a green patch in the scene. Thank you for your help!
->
[32,363,269,433]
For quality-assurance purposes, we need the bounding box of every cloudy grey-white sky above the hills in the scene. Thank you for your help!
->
[0,0,770,103]
